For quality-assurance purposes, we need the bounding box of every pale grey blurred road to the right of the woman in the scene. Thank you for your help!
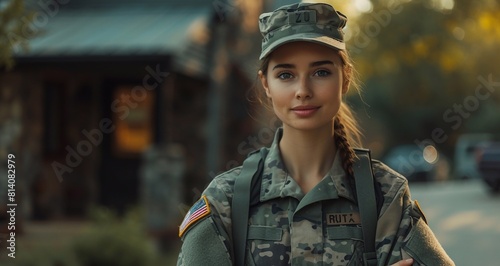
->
[410,180,500,266]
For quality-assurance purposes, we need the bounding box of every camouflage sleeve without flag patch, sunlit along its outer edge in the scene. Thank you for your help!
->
[376,174,455,266]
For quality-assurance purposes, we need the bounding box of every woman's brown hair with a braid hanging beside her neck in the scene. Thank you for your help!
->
[255,50,361,177]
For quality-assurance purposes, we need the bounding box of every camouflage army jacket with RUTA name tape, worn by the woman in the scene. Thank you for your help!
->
[177,130,454,266]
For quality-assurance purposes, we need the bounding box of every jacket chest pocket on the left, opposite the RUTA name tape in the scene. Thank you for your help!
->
[246,225,290,265]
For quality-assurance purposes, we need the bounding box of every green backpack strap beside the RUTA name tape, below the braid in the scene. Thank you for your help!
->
[353,149,378,266]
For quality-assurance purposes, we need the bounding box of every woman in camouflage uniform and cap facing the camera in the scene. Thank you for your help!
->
[178,3,453,265]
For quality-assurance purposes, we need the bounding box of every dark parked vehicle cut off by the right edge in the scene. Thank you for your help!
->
[477,142,500,193]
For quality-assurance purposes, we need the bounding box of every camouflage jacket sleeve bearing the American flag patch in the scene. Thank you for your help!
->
[177,169,239,266]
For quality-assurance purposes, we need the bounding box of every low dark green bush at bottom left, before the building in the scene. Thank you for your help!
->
[73,209,157,266]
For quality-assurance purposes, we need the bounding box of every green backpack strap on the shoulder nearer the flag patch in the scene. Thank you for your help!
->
[231,148,268,266]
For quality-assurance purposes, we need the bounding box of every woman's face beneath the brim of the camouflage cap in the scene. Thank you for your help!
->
[259,42,348,133]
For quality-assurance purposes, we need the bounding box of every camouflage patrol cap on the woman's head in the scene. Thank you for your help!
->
[259,3,347,59]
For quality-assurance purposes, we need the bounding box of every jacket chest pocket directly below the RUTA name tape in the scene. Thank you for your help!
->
[325,226,364,265]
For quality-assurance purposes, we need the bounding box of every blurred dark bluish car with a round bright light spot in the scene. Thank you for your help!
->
[383,144,449,182]
